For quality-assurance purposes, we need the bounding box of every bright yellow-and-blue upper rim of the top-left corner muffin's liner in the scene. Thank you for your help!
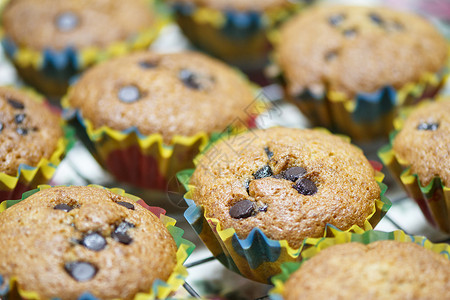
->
[0,0,169,73]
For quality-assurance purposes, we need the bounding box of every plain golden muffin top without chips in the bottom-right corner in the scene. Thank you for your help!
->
[283,241,450,300]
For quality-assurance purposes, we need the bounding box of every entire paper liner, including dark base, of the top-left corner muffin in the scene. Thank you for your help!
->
[0,0,168,96]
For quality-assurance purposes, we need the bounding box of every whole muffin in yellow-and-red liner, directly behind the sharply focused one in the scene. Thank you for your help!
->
[63,52,260,191]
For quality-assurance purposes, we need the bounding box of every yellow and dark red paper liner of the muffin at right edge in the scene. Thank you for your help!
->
[378,107,450,233]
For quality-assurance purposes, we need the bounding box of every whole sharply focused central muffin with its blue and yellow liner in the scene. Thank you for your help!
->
[181,128,390,283]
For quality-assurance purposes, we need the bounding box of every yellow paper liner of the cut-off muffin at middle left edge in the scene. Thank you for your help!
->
[0,89,75,202]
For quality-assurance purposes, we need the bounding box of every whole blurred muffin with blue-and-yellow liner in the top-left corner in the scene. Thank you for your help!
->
[2,0,166,97]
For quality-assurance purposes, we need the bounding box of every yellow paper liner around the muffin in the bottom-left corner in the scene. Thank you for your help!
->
[0,185,195,300]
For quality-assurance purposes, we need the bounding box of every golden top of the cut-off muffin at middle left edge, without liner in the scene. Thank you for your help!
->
[0,87,63,176]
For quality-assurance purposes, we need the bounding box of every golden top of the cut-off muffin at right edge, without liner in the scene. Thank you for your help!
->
[393,98,450,186]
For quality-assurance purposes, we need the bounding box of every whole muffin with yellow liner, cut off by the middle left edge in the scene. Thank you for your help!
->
[0,87,73,202]
